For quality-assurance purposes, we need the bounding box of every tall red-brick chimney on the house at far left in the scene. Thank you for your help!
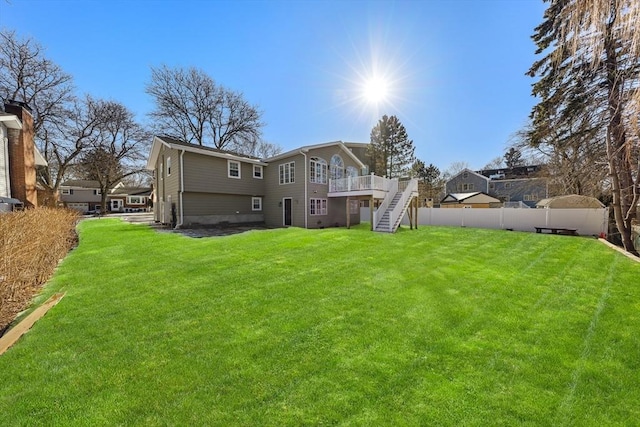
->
[4,100,38,207]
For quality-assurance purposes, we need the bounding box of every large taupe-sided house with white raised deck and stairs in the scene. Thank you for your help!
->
[147,136,417,231]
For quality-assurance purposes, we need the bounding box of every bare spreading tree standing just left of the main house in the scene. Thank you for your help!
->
[78,101,151,211]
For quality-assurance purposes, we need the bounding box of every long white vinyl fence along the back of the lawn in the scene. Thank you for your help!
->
[360,208,609,236]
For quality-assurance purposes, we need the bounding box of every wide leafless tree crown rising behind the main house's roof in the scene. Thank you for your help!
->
[146,65,264,154]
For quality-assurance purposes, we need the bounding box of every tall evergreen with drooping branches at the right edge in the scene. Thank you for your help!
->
[528,0,640,253]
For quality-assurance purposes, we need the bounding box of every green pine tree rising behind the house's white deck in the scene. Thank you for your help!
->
[368,115,415,178]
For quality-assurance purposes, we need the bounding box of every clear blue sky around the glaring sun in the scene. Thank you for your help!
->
[0,0,545,170]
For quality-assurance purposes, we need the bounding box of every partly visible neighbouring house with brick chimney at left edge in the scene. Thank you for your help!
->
[0,101,47,207]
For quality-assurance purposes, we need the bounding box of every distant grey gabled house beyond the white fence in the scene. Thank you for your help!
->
[445,166,548,207]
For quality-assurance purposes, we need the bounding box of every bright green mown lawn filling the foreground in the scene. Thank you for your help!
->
[0,219,640,426]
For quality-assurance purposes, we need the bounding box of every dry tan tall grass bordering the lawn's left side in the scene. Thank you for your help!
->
[0,208,79,335]
